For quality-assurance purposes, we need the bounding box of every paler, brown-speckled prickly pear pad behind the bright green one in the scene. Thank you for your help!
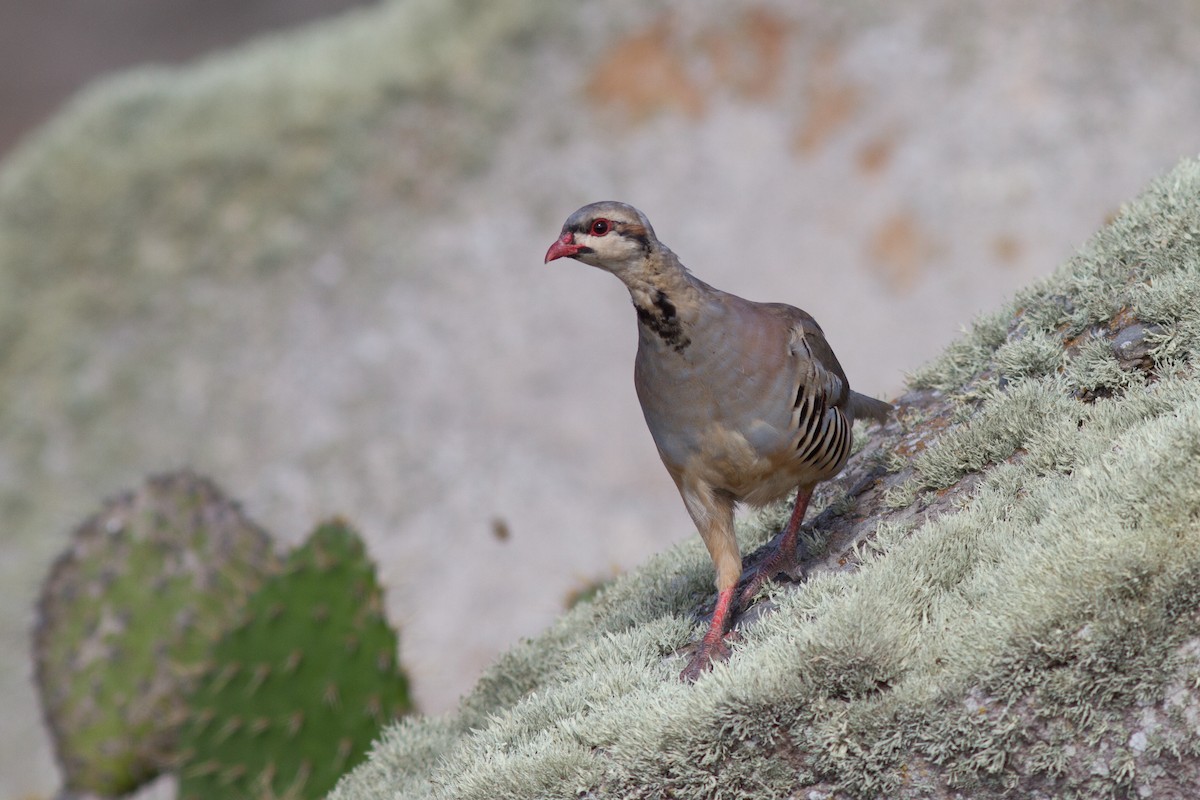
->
[34,473,276,795]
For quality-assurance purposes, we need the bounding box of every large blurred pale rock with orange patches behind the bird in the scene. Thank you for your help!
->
[0,0,1200,796]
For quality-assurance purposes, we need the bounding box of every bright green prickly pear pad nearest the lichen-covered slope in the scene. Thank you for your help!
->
[179,521,409,800]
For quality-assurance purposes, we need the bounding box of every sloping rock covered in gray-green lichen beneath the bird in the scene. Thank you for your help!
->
[331,161,1200,800]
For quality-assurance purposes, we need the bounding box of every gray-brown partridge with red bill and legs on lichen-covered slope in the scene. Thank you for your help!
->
[544,200,893,682]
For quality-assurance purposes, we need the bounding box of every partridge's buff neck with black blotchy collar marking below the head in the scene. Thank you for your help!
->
[620,247,704,353]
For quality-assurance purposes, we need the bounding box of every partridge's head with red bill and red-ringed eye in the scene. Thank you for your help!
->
[546,200,661,275]
